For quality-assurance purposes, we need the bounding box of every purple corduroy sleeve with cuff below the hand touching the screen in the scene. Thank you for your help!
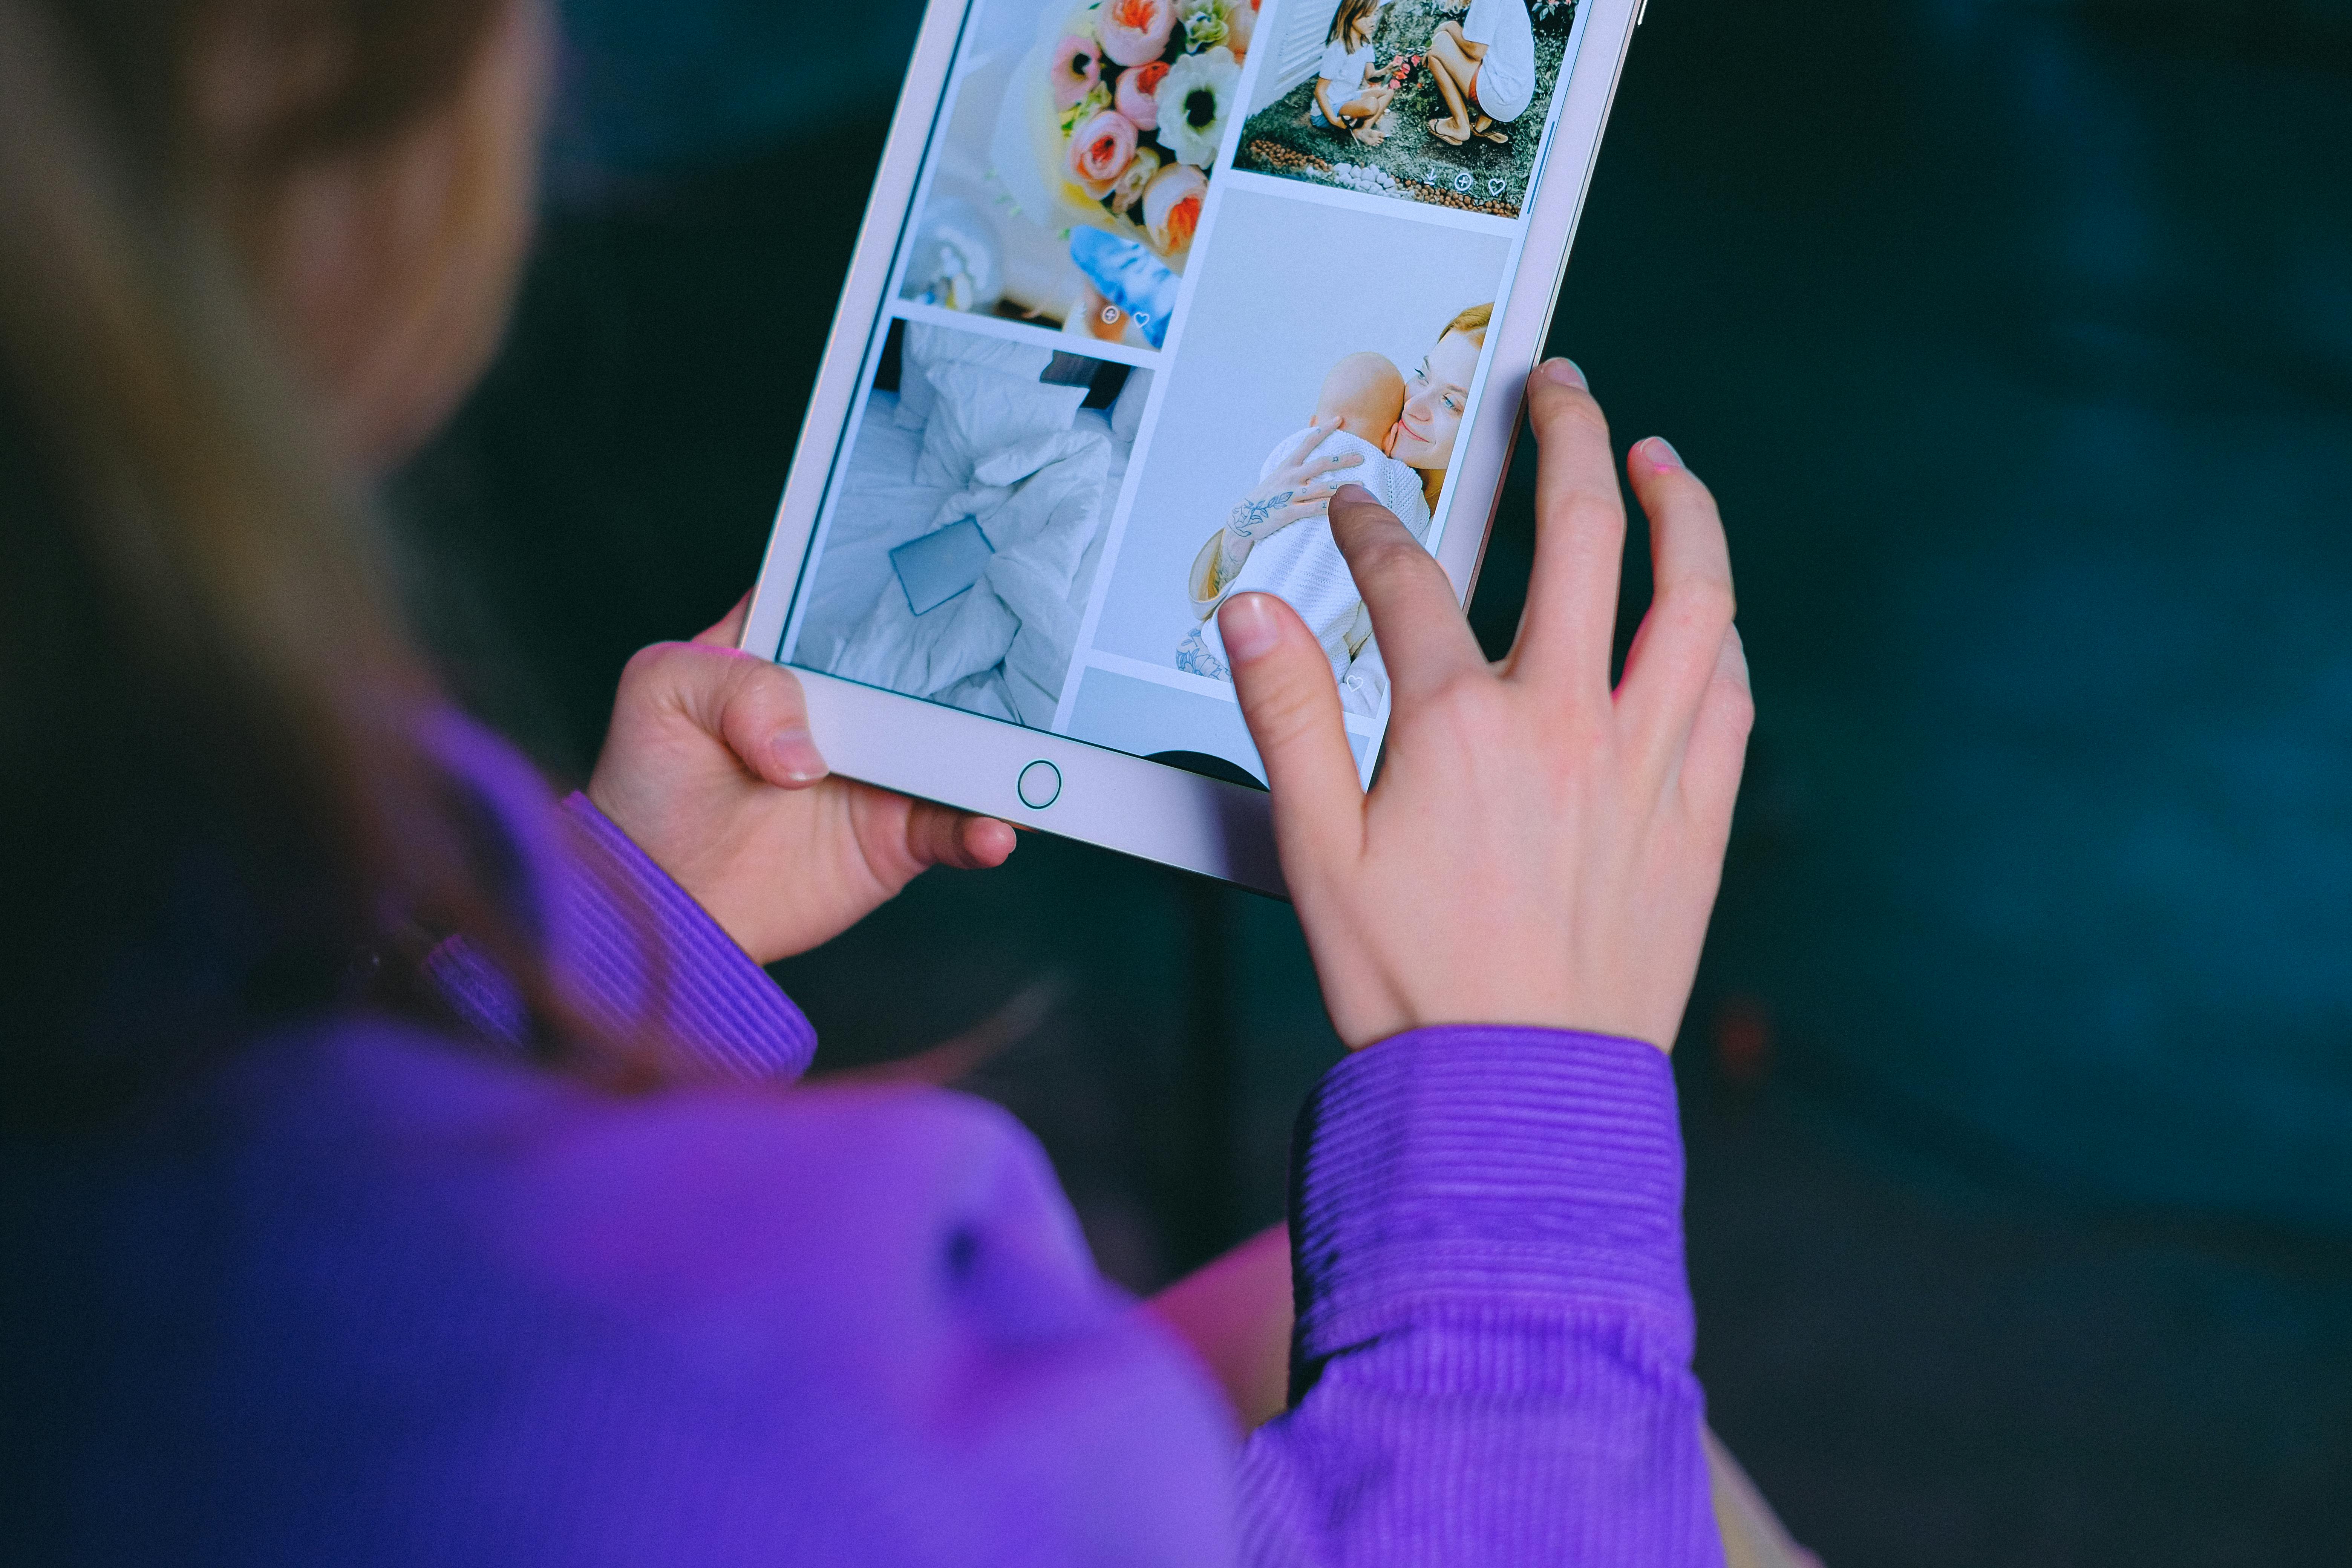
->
[1242,1027,1722,1566]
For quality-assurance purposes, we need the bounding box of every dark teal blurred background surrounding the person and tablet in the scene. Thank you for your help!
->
[400,0,2352,1568]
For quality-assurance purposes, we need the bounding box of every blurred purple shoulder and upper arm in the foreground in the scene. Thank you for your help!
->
[28,1018,1230,1563]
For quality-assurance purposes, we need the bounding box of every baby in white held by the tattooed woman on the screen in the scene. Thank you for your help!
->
[1176,353,1430,712]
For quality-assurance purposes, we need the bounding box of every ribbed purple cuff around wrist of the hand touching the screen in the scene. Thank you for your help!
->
[1291,1027,1694,1363]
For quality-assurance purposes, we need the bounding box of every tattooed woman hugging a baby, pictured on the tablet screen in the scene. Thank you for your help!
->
[1176,303,1493,715]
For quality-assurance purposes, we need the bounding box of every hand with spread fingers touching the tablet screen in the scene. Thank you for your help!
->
[1218,360,1755,1049]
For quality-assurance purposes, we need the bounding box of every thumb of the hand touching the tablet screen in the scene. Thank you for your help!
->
[1216,593,1364,886]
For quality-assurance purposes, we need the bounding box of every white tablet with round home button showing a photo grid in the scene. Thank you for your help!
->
[743,0,1639,896]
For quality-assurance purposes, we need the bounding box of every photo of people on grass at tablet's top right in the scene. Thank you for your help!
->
[1233,0,1576,219]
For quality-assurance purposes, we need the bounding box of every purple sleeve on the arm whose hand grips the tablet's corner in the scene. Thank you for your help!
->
[426,795,816,1084]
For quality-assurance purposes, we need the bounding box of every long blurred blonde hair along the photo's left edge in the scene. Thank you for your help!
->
[0,0,663,1117]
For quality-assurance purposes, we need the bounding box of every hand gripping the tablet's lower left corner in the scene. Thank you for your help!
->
[588,599,1014,964]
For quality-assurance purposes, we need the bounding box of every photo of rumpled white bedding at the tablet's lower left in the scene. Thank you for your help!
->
[790,322,1150,729]
